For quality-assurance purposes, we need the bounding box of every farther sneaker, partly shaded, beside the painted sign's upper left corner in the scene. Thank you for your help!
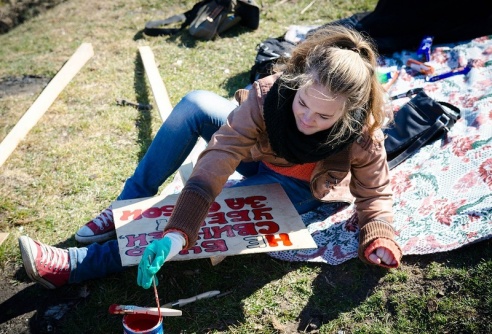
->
[75,205,116,244]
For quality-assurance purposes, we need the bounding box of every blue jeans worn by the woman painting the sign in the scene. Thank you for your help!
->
[69,91,321,283]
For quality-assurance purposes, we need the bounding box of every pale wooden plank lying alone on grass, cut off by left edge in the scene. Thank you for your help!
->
[0,43,94,166]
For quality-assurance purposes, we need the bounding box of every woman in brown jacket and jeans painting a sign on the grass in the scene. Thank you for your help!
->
[19,26,402,289]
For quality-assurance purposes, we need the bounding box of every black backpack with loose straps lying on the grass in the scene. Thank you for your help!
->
[144,0,260,40]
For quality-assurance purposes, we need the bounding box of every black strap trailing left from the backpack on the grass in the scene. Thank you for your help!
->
[144,0,212,36]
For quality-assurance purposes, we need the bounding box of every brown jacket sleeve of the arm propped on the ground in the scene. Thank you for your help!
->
[350,133,402,264]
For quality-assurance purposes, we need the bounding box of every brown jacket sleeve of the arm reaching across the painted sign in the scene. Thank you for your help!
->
[164,85,264,248]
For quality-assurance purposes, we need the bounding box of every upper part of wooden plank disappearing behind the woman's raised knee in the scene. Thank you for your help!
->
[138,46,173,122]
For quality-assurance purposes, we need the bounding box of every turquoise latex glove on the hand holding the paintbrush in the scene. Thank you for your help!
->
[137,236,172,289]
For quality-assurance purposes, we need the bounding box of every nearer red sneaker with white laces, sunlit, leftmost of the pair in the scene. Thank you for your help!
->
[19,236,70,289]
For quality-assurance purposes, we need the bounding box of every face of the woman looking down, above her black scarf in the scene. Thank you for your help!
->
[292,84,346,135]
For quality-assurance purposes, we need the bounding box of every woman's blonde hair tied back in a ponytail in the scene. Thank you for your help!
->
[274,25,387,144]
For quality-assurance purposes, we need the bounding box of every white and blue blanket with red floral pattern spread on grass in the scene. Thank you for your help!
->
[164,36,492,265]
